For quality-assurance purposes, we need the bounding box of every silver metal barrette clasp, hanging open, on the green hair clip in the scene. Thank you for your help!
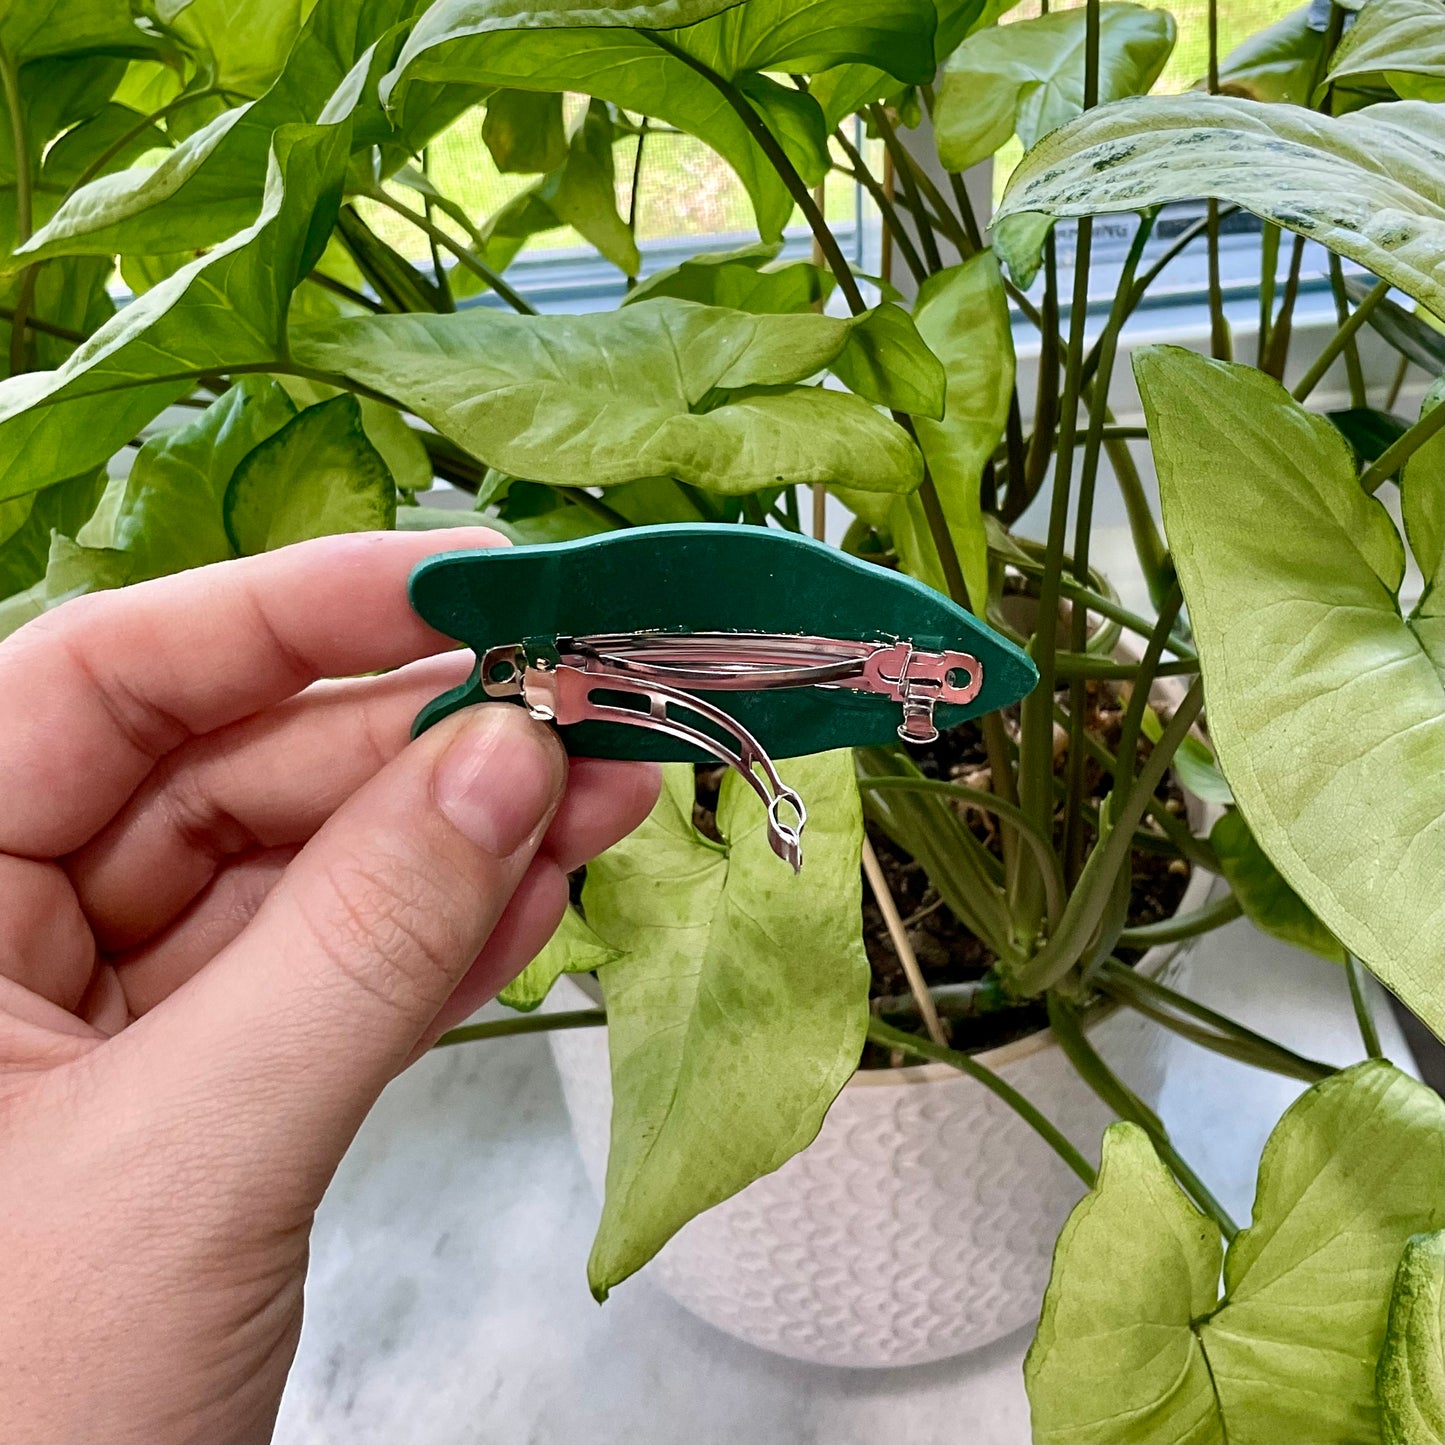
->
[480,631,984,873]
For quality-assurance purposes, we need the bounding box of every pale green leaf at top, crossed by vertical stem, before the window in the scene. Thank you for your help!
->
[933,0,1176,171]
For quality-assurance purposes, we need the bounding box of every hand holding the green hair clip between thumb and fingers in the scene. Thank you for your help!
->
[0,529,657,1442]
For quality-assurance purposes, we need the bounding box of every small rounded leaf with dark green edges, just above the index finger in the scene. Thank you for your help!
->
[221,396,396,556]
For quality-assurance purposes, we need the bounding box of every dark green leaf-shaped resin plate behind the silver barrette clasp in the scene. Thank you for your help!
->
[410,523,1038,763]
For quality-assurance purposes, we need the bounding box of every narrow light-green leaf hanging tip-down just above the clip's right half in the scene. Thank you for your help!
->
[890,251,1014,616]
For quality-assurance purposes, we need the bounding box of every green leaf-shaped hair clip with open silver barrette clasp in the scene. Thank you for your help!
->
[410,523,1038,868]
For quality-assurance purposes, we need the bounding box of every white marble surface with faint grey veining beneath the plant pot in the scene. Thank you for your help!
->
[276,923,1407,1445]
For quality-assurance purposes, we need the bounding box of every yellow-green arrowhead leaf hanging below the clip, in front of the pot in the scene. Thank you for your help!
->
[582,751,868,1299]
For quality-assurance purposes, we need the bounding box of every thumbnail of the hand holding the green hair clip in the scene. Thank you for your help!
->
[432,704,566,858]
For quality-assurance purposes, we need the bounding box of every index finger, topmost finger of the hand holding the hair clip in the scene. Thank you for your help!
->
[0,527,504,858]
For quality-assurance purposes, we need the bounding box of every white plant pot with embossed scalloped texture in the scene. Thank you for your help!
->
[548,832,1211,1367]
